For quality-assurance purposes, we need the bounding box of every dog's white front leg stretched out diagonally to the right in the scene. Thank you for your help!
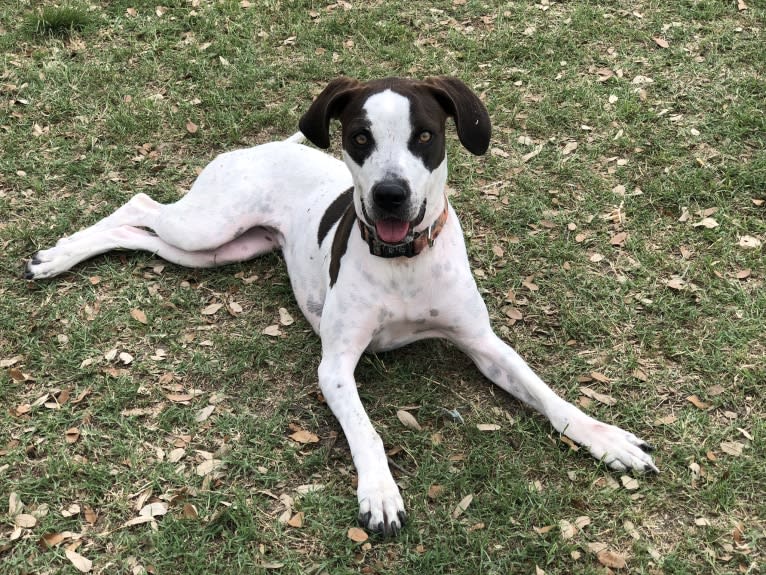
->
[455,322,658,473]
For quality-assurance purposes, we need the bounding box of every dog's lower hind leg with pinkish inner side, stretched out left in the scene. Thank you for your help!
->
[24,224,279,279]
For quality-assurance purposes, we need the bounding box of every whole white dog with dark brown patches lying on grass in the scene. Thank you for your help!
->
[25,77,658,535]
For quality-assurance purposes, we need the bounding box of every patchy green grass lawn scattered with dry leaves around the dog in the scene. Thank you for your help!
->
[0,0,766,575]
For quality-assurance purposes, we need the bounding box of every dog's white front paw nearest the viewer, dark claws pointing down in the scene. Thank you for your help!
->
[357,475,407,537]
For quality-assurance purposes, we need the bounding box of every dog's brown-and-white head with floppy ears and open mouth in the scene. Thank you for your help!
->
[300,77,491,244]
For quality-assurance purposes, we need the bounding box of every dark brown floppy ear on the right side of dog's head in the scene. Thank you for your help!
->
[423,76,492,156]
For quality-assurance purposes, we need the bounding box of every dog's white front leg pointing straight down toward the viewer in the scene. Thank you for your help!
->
[319,348,406,535]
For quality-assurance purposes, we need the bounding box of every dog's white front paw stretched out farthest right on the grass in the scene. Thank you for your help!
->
[562,413,659,473]
